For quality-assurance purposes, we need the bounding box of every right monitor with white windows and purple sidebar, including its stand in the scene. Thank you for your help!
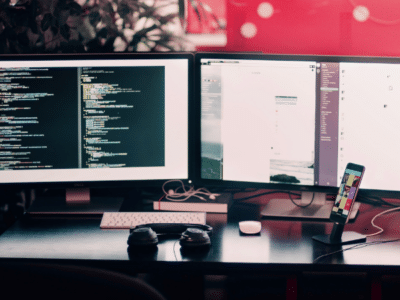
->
[195,53,400,218]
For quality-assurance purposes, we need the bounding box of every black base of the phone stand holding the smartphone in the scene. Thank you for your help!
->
[312,223,367,245]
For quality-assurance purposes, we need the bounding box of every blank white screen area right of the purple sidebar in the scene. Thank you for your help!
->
[338,63,400,190]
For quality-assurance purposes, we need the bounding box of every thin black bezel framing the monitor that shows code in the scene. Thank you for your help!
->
[0,52,195,189]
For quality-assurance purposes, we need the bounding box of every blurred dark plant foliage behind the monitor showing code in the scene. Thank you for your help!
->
[0,0,185,54]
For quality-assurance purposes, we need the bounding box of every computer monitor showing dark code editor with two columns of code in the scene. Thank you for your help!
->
[0,53,194,211]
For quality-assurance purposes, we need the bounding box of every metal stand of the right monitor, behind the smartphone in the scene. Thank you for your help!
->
[261,192,360,221]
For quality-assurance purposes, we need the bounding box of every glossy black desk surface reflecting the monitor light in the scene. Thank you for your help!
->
[0,198,400,273]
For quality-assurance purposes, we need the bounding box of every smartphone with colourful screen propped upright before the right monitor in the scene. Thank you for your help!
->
[330,163,365,224]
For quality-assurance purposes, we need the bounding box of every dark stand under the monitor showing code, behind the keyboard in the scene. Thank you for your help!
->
[27,188,124,215]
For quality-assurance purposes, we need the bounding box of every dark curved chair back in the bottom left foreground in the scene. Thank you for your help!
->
[0,261,165,300]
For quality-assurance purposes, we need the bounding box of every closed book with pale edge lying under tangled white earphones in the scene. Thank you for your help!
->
[153,193,233,213]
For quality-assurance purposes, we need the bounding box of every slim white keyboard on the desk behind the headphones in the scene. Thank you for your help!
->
[100,212,206,229]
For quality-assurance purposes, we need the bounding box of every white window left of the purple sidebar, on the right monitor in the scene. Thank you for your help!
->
[211,61,316,185]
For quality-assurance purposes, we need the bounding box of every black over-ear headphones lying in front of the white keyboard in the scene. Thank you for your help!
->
[128,223,213,250]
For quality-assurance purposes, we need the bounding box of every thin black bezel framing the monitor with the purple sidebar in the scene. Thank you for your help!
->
[193,52,400,198]
